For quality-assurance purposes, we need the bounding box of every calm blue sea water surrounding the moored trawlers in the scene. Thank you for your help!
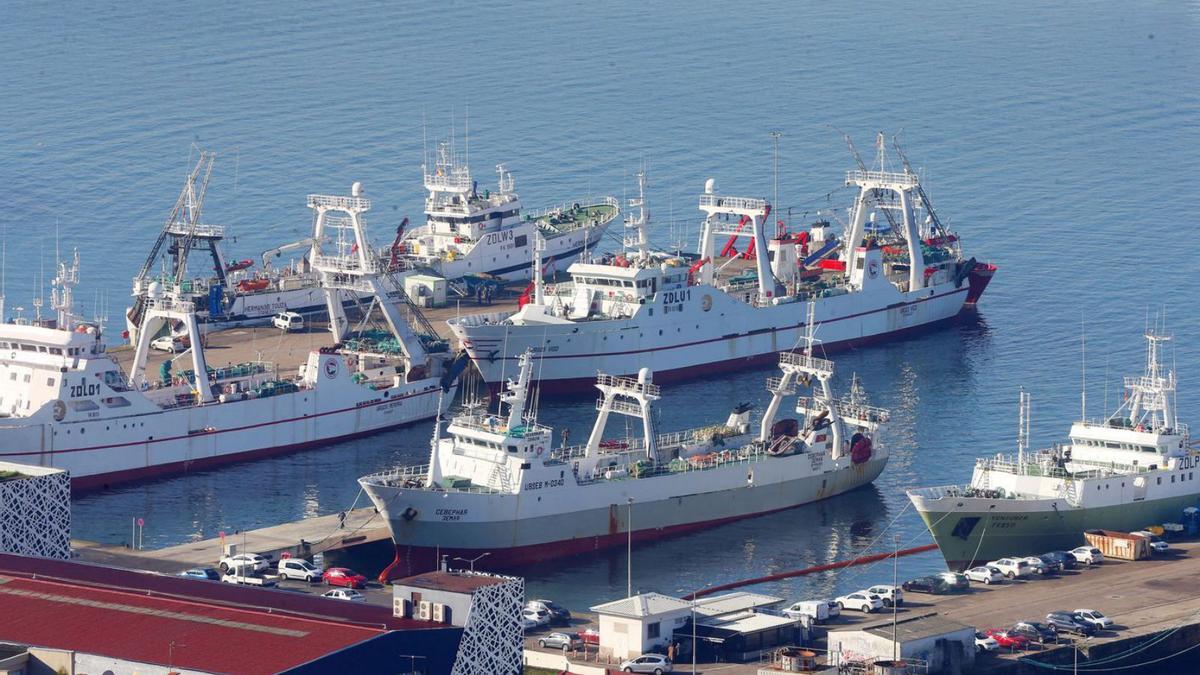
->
[0,0,1200,607]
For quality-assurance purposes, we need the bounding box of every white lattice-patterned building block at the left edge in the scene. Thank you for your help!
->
[0,461,71,560]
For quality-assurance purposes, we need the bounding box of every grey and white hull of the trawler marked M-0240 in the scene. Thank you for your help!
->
[364,455,887,578]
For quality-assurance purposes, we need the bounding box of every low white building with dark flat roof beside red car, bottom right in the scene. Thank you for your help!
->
[828,613,976,673]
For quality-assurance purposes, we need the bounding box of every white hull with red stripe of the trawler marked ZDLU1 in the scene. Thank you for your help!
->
[449,278,970,393]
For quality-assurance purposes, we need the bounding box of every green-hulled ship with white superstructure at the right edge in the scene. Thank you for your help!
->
[908,331,1200,568]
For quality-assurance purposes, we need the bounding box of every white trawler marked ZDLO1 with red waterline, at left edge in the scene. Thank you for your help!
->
[0,174,467,490]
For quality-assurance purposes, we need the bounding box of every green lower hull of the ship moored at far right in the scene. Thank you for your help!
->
[910,494,1200,569]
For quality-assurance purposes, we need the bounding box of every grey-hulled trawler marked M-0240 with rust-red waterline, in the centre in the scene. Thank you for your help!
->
[359,312,888,579]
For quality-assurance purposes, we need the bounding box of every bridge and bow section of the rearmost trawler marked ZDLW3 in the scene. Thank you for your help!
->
[394,143,620,280]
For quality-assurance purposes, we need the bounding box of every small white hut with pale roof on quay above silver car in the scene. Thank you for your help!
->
[592,593,692,659]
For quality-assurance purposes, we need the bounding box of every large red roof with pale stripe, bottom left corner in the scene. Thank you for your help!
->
[0,575,384,673]
